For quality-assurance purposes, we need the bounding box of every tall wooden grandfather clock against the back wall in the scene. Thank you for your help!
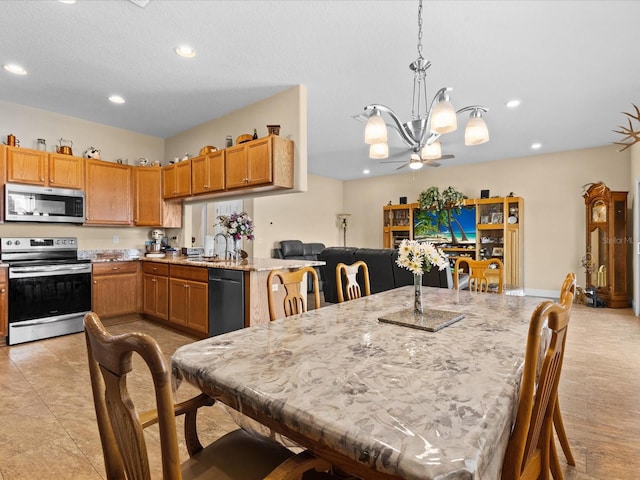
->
[583,182,629,308]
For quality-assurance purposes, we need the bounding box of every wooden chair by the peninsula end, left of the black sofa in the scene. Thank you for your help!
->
[267,267,320,320]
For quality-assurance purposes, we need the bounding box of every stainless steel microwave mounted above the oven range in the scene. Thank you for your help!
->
[4,183,85,223]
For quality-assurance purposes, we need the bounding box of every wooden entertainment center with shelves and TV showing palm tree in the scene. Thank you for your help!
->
[382,197,524,290]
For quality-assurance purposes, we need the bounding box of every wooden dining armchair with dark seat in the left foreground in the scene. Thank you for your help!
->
[84,312,328,480]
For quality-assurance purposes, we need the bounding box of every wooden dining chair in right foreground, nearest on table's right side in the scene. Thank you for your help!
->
[502,291,573,480]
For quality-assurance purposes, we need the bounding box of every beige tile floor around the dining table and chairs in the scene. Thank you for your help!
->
[0,305,640,480]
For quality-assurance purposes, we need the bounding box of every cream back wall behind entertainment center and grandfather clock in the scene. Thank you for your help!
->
[344,146,632,295]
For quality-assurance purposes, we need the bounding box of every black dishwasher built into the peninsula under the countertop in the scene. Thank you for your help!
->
[209,268,244,337]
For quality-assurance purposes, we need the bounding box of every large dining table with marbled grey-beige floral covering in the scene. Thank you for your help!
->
[171,286,545,480]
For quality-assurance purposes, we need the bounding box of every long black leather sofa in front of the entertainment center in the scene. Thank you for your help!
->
[318,247,453,303]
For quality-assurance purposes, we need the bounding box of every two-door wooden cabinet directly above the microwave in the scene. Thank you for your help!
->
[6,147,85,189]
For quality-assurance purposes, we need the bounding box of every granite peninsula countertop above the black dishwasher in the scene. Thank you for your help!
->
[140,255,325,272]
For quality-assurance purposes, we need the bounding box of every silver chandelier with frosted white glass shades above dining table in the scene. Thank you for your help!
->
[364,0,489,169]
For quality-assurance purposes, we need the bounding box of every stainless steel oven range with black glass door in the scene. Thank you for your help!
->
[0,237,91,345]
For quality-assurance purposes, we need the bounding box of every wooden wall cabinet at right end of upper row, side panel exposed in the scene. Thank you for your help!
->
[225,135,293,189]
